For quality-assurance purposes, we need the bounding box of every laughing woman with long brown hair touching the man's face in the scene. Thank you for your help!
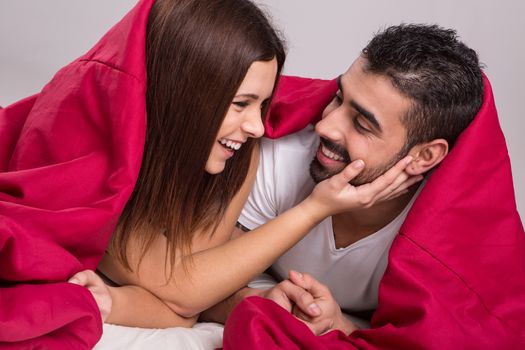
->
[71,0,414,327]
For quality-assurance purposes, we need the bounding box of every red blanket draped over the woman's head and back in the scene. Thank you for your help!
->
[0,0,153,349]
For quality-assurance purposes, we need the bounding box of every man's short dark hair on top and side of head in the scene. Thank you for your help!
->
[362,24,483,148]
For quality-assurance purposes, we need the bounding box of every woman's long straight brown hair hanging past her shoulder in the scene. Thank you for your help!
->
[109,0,285,270]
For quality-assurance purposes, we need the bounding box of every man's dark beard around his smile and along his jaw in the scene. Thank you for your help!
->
[310,138,410,186]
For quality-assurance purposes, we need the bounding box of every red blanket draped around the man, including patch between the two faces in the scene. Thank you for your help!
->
[224,74,525,350]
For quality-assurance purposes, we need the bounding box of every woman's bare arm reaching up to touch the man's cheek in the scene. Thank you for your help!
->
[99,148,407,317]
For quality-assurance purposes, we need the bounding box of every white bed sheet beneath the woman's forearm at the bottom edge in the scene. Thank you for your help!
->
[94,323,223,350]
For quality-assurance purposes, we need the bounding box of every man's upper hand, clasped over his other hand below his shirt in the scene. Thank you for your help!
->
[289,271,357,335]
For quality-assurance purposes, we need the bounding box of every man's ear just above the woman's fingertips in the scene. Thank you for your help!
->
[405,139,448,175]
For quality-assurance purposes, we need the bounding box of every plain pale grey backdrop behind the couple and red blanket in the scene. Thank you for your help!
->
[0,0,525,219]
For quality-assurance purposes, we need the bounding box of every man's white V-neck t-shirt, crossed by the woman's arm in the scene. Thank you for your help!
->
[239,127,422,313]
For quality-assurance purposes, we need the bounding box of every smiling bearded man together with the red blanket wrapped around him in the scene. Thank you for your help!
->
[209,25,525,349]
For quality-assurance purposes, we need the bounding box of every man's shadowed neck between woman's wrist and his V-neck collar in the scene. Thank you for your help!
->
[332,185,419,248]
